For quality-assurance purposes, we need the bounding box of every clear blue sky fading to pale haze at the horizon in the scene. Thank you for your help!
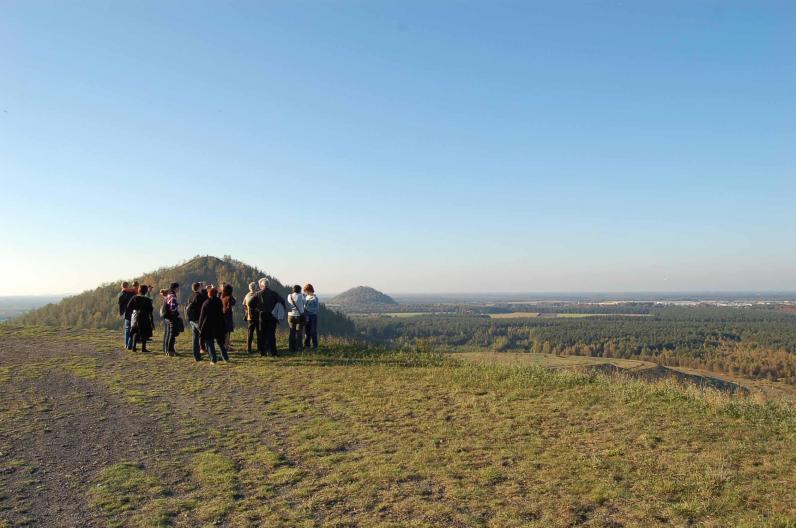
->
[0,0,796,295]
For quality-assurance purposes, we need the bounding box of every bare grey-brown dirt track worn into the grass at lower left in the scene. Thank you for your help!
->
[0,340,185,527]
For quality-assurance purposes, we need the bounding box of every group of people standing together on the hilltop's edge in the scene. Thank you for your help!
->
[118,278,320,364]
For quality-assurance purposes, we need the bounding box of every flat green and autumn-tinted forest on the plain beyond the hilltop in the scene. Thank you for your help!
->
[356,306,796,384]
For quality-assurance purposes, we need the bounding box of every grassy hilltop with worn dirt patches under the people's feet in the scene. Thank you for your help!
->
[0,325,796,527]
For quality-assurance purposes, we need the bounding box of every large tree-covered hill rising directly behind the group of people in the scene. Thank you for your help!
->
[18,256,355,335]
